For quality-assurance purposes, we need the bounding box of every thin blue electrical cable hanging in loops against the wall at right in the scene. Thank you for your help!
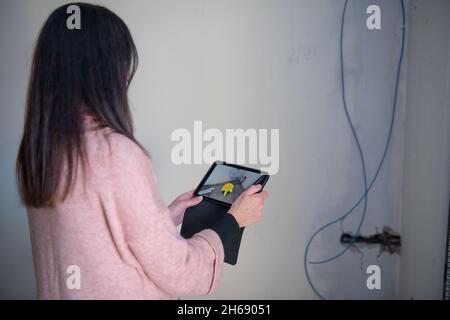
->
[303,0,405,299]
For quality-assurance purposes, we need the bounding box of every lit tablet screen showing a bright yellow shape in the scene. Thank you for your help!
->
[196,163,268,205]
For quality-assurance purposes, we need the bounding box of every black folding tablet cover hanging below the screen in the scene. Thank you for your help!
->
[181,197,244,265]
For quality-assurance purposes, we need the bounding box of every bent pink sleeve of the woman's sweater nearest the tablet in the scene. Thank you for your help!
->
[102,137,224,296]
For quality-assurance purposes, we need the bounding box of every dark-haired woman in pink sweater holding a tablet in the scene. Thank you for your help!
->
[17,3,267,299]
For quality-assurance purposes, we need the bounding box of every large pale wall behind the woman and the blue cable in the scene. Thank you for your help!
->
[0,0,446,298]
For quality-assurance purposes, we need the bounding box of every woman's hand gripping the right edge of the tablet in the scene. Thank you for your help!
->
[229,184,269,228]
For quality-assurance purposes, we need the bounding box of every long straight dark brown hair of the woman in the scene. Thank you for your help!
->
[16,3,138,208]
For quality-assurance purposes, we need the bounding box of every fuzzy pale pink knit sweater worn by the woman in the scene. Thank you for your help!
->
[28,125,224,299]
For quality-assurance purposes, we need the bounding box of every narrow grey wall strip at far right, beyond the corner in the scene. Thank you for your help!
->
[399,0,450,299]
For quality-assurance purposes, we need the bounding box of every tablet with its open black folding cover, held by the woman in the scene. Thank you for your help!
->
[181,162,269,265]
